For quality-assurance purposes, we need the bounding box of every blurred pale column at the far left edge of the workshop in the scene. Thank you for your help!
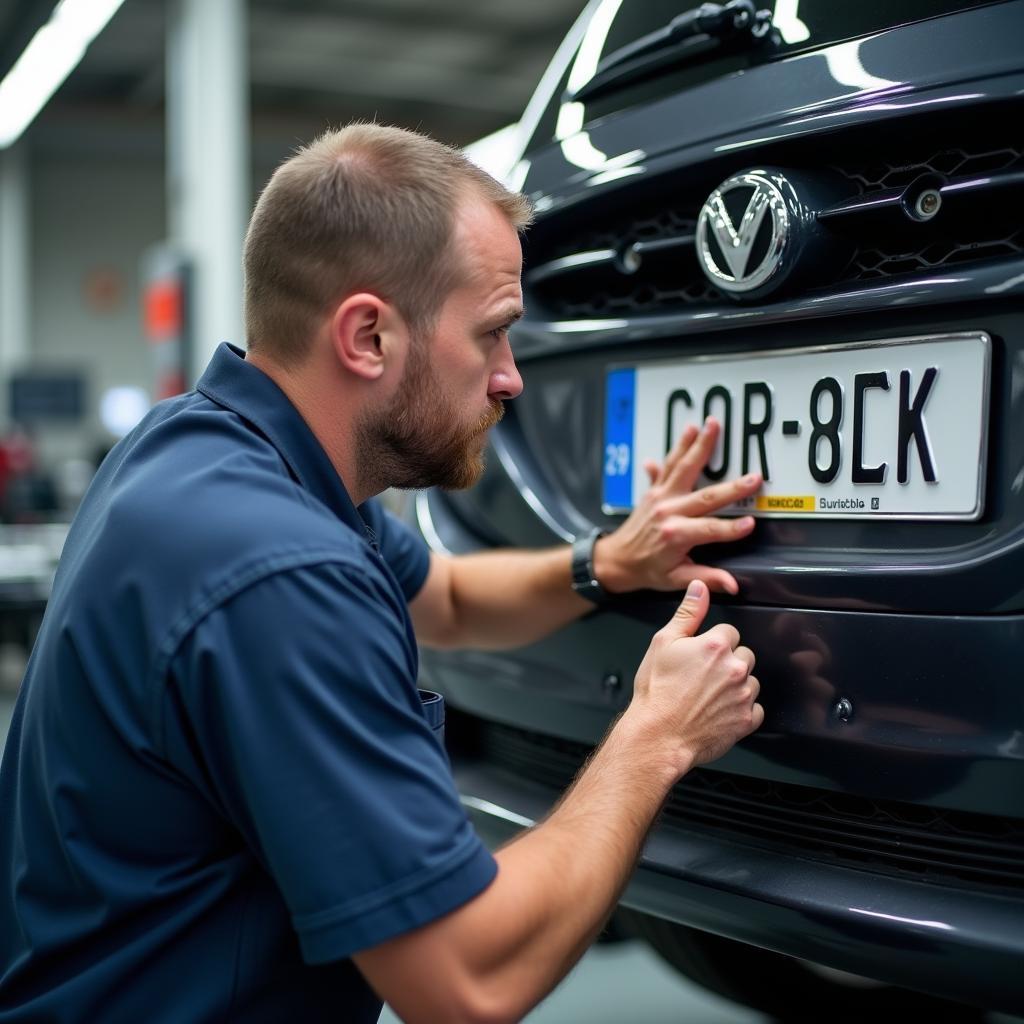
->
[0,141,32,422]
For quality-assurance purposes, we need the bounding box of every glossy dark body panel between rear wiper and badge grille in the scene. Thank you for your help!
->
[524,0,1024,216]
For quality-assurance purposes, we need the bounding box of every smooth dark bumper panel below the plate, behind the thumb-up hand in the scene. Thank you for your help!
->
[415,487,1024,818]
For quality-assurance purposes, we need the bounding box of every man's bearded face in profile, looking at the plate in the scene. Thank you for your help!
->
[359,200,522,489]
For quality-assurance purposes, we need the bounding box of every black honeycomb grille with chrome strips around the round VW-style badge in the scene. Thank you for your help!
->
[524,112,1024,319]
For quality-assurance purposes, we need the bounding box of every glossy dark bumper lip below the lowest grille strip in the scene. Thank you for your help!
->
[454,760,1024,1014]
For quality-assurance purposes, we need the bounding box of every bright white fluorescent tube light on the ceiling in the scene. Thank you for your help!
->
[0,0,124,148]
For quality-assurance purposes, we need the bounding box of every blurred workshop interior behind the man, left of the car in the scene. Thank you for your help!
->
[0,0,583,712]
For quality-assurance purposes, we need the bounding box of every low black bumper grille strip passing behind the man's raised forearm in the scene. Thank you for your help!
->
[471,719,1024,894]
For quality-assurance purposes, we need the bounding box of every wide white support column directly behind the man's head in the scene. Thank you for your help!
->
[167,0,251,384]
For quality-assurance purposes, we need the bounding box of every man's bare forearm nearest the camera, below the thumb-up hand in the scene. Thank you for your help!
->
[356,712,686,1021]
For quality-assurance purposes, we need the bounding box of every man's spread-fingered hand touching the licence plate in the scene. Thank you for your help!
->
[594,418,762,594]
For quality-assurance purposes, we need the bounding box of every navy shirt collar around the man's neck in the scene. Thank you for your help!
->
[196,343,367,534]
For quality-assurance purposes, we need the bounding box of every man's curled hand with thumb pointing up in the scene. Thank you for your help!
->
[624,581,764,778]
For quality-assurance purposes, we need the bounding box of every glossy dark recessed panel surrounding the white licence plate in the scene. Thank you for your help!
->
[456,311,1024,614]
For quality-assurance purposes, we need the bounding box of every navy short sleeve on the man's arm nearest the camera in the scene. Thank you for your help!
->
[162,563,496,964]
